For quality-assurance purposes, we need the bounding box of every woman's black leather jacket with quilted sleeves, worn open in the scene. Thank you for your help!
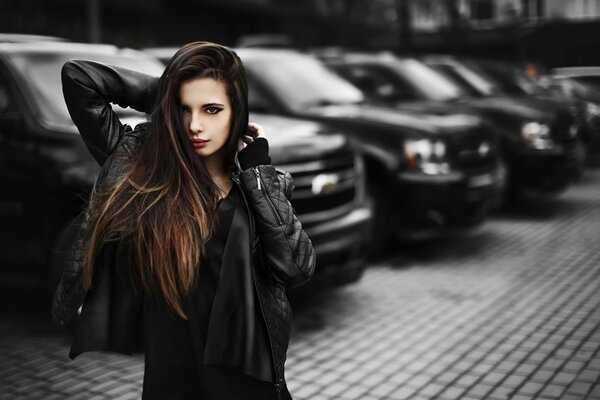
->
[52,61,316,391]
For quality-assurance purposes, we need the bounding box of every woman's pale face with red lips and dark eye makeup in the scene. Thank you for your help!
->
[179,78,232,161]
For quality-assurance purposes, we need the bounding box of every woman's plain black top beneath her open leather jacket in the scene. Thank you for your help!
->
[143,186,273,400]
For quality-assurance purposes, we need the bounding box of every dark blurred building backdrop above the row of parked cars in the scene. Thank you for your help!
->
[0,0,600,66]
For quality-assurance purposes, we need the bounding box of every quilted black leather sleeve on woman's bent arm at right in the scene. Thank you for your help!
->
[240,165,316,286]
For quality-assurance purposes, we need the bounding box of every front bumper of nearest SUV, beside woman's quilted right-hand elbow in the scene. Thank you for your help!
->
[304,204,371,288]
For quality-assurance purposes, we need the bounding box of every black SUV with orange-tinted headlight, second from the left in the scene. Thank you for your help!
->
[236,48,501,247]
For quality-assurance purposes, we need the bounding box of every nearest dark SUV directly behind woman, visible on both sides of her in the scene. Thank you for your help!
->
[0,42,370,289]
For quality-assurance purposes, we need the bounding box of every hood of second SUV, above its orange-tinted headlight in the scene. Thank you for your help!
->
[309,105,482,135]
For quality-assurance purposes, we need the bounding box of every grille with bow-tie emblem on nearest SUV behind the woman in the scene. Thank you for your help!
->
[278,151,364,224]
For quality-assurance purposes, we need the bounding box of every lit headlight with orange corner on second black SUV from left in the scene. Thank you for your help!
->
[404,139,450,175]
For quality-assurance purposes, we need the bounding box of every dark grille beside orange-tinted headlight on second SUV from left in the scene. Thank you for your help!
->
[448,130,498,170]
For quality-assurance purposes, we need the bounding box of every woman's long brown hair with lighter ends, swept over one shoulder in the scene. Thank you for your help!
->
[83,42,248,318]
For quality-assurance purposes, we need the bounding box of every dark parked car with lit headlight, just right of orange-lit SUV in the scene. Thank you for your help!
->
[424,56,584,195]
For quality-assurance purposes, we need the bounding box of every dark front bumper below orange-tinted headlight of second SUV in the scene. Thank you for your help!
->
[392,168,506,238]
